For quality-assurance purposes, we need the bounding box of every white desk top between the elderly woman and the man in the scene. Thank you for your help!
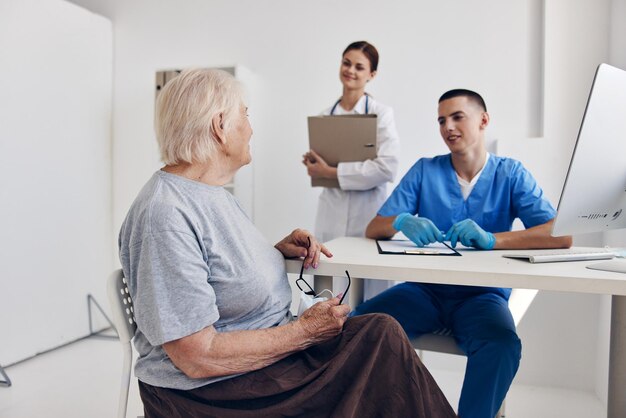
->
[286,237,626,295]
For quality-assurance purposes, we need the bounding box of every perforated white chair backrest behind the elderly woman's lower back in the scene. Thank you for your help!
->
[107,269,137,343]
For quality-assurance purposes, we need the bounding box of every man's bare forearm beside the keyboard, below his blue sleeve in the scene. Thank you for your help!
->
[493,220,572,250]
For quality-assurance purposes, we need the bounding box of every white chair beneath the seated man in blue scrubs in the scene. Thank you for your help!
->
[411,289,538,418]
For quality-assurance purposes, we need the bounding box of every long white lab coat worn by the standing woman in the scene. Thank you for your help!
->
[315,95,400,300]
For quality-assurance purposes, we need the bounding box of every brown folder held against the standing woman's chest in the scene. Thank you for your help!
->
[308,114,378,188]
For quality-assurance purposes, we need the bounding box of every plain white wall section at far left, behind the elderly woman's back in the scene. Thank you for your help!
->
[0,0,113,365]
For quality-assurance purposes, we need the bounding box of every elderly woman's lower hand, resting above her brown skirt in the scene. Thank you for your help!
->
[295,296,350,344]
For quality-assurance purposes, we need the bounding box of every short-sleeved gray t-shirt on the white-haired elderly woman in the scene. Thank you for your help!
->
[119,171,292,390]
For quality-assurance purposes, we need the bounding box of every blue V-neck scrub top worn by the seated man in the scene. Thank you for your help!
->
[378,154,556,299]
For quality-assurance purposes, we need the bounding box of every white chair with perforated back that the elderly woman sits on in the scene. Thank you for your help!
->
[107,269,137,418]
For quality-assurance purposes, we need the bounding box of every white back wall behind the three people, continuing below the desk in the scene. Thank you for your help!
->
[100,0,621,396]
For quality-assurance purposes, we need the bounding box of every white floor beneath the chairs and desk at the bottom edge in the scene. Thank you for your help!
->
[0,337,606,418]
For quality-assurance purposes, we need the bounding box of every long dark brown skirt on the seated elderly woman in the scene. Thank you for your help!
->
[139,314,456,418]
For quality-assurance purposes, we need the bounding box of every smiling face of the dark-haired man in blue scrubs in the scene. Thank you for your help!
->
[437,96,489,154]
